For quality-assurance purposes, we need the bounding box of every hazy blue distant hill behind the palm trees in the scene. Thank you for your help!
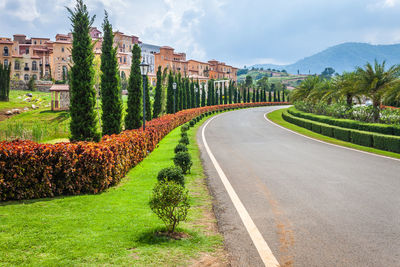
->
[250,43,400,74]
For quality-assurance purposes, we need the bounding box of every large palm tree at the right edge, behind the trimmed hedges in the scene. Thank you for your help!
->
[356,60,400,122]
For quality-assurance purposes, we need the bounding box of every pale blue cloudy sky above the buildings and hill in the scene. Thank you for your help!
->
[0,0,400,67]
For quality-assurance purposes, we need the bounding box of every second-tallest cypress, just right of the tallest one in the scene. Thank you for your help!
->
[100,12,122,135]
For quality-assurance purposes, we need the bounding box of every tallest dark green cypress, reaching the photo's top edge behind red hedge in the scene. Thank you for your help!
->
[67,0,101,141]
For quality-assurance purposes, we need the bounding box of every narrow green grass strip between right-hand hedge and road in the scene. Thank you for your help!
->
[267,109,400,159]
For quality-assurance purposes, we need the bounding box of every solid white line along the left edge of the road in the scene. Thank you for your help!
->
[201,116,279,267]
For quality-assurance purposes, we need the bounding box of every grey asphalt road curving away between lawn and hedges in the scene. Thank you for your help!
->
[198,107,400,267]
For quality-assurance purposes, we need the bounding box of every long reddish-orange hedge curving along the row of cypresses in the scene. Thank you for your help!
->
[0,103,286,201]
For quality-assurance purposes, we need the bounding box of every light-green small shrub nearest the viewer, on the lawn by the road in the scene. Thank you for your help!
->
[149,181,190,233]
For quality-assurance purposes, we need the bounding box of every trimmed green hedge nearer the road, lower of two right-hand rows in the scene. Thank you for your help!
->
[282,111,400,153]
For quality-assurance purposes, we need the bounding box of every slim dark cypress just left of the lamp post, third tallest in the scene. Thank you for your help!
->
[125,44,143,130]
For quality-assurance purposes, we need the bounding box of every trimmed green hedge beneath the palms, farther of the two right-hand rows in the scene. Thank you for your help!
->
[288,107,400,136]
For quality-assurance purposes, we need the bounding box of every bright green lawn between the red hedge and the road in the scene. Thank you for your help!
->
[0,117,223,266]
